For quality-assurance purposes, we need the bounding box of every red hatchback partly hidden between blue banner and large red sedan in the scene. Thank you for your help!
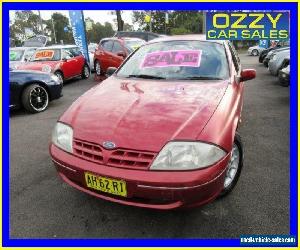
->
[93,37,145,75]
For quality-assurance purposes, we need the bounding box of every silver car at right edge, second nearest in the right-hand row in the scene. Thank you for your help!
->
[268,50,290,76]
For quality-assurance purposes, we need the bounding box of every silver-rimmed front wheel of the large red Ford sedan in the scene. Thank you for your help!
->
[220,133,244,197]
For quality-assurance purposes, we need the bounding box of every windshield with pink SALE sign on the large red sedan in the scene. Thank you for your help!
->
[117,40,229,80]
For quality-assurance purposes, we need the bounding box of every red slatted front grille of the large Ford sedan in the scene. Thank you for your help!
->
[73,139,156,169]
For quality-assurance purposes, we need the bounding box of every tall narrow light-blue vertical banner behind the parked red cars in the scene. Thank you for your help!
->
[69,10,89,62]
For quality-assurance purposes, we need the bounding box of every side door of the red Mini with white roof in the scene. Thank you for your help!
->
[61,49,80,79]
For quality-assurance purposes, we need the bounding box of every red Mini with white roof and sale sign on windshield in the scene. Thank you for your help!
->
[18,45,90,83]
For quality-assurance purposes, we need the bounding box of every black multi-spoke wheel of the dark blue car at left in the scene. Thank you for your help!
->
[22,84,49,113]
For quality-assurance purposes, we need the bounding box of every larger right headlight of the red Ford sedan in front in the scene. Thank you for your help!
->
[150,142,226,170]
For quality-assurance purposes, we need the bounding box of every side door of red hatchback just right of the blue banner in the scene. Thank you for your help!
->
[94,39,113,71]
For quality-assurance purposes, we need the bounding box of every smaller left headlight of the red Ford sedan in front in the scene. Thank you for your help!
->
[52,122,73,153]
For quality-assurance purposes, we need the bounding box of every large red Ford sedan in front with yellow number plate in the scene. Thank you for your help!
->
[50,35,256,209]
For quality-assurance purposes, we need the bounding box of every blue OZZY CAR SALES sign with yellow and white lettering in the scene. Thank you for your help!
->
[206,11,289,40]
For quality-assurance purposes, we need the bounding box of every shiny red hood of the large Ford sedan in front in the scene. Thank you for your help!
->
[60,76,228,152]
